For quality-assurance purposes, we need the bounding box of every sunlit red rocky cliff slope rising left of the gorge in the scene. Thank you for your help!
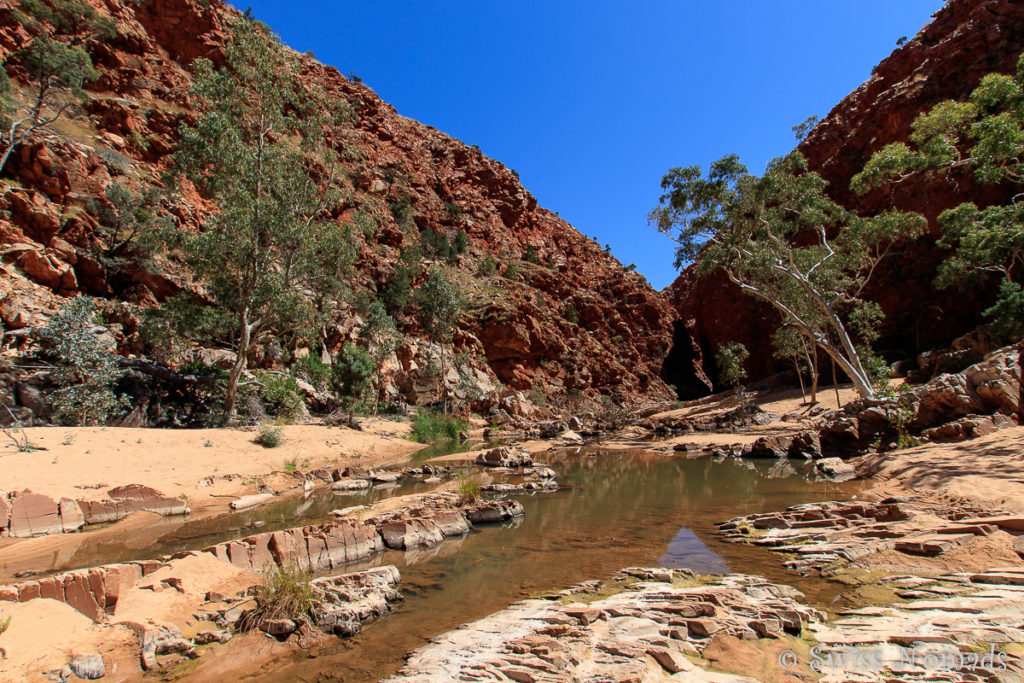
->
[0,0,675,411]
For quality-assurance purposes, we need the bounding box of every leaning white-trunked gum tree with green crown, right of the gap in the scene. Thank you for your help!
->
[651,153,927,397]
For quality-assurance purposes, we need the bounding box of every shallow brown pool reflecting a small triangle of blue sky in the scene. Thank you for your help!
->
[237,452,862,683]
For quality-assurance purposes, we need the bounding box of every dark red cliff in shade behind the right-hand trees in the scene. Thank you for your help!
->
[666,0,1024,395]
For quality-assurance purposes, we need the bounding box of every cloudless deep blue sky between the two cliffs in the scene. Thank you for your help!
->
[236,0,942,289]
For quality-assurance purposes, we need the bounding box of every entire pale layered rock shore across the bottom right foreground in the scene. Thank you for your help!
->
[386,568,1024,683]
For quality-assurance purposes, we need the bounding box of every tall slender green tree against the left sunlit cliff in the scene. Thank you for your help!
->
[167,18,354,419]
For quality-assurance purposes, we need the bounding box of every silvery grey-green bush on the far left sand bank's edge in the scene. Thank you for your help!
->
[42,296,129,425]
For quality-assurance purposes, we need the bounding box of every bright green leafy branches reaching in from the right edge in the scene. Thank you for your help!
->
[851,55,1024,340]
